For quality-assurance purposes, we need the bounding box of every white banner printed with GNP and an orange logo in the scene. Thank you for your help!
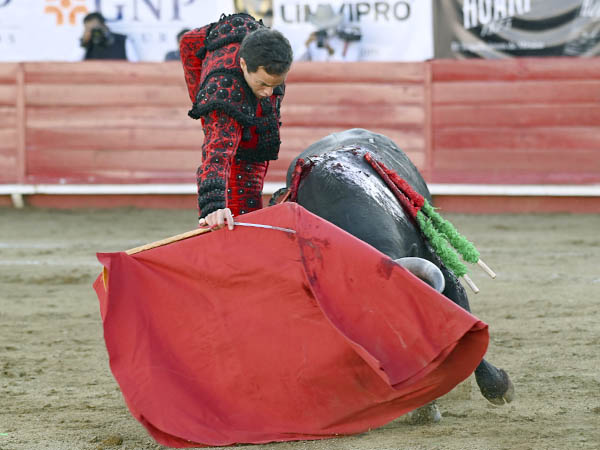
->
[0,0,233,61]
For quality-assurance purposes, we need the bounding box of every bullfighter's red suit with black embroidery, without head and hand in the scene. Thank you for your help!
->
[180,14,284,217]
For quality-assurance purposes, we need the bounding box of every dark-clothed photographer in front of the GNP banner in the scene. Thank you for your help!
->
[79,12,139,62]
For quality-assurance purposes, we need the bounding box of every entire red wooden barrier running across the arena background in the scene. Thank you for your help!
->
[0,58,600,212]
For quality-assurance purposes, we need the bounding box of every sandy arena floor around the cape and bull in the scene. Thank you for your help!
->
[0,208,600,450]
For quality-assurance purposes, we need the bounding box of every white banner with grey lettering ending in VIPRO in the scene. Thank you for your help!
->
[270,0,433,61]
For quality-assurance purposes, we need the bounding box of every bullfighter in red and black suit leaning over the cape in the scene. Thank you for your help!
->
[180,14,293,229]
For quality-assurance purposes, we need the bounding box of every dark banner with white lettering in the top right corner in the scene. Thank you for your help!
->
[434,0,600,58]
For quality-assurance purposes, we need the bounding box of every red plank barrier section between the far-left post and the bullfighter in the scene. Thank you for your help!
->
[22,62,192,183]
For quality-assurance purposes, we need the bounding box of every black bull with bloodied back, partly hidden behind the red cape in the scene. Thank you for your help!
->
[274,128,514,404]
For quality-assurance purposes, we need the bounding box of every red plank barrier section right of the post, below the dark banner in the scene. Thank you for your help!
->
[431,58,600,184]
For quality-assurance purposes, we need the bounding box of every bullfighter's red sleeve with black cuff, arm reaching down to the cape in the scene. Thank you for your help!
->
[197,111,242,218]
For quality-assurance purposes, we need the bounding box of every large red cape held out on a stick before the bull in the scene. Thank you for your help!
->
[94,203,488,447]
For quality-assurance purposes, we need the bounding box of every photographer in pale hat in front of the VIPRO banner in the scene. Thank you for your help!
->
[298,5,362,61]
